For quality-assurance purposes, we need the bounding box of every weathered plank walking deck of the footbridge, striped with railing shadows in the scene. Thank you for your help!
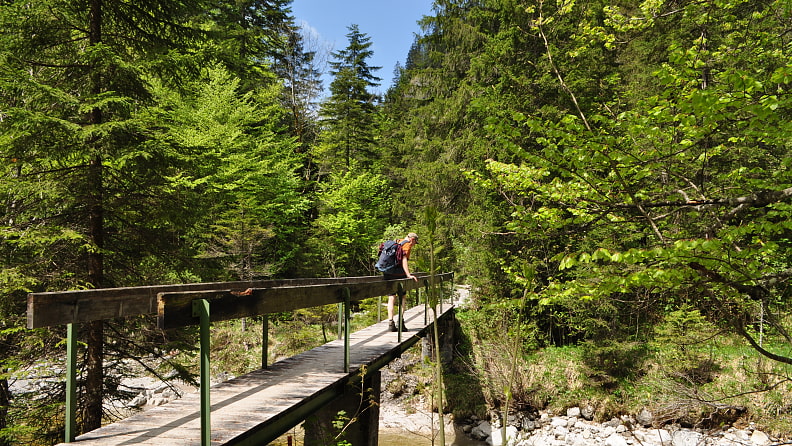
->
[62,305,451,446]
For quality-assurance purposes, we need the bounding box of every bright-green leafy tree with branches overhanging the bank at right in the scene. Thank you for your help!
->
[480,2,792,363]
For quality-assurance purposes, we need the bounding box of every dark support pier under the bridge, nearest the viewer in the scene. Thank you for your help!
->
[303,370,381,446]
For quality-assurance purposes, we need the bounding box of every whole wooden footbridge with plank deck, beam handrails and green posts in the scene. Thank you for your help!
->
[28,273,453,446]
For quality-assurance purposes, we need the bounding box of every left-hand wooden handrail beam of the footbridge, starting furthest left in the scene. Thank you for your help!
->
[27,276,408,328]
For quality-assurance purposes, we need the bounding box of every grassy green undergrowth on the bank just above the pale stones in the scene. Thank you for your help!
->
[447,310,792,437]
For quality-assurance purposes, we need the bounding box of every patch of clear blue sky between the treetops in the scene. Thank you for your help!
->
[291,0,433,93]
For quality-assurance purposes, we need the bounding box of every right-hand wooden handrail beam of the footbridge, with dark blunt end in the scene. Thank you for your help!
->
[157,273,453,329]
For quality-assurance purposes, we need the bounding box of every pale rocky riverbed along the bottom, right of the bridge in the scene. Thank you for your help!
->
[380,358,792,446]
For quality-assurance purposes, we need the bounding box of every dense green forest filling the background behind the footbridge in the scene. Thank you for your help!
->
[0,0,792,445]
